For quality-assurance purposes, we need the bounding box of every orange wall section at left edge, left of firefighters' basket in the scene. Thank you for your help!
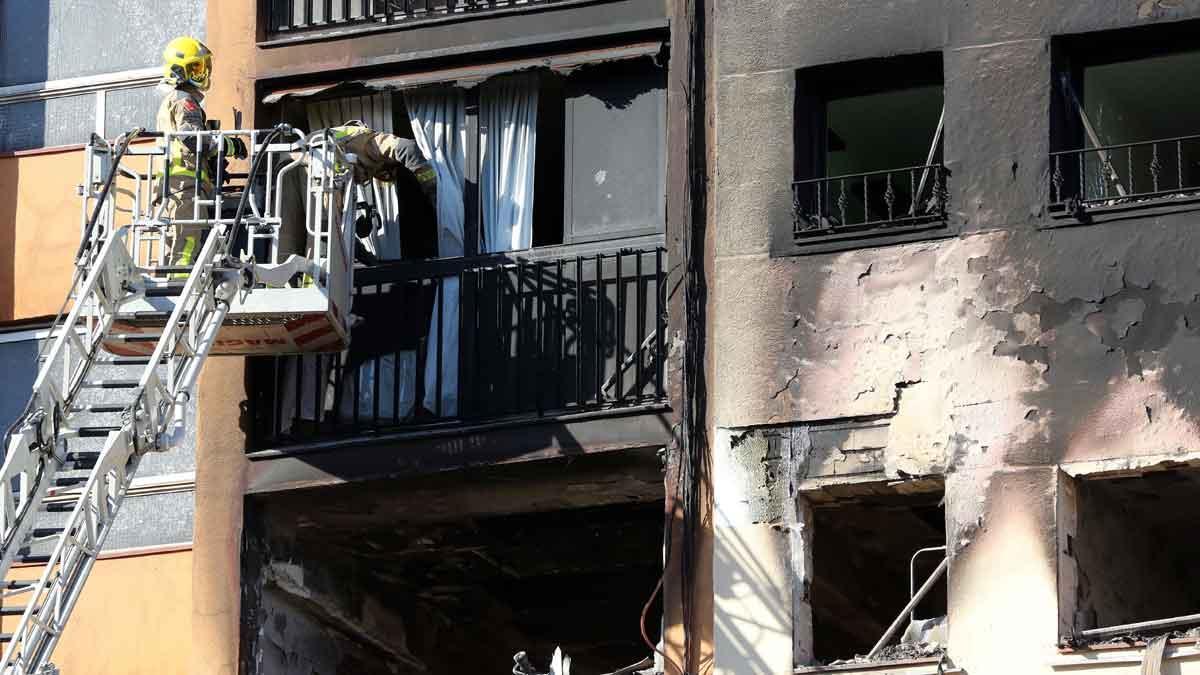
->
[0,149,83,322]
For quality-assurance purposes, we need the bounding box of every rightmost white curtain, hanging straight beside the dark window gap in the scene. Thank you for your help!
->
[479,73,538,252]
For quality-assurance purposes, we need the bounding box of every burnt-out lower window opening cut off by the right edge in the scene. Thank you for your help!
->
[1058,468,1200,646]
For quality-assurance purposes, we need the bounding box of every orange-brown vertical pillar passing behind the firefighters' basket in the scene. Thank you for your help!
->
[190,0,258,675]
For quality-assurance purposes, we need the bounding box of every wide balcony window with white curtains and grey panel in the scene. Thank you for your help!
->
[267,56,666,259]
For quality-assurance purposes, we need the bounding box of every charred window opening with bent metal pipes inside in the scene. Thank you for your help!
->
[811,491,947,665]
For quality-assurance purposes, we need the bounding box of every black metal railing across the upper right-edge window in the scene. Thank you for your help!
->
[1050,136,1200,215]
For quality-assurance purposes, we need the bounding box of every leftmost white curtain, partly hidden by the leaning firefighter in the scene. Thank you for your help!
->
[306,92,403,261]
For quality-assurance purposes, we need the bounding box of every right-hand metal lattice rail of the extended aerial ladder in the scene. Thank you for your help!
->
[0,222,242,675]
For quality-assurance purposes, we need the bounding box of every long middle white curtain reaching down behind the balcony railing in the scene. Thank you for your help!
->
[404,88,467,416]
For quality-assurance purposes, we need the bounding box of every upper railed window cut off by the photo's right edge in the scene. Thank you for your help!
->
[1049,22,1200,220]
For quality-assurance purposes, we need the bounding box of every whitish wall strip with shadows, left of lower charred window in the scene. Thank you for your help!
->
[713,430,796,675]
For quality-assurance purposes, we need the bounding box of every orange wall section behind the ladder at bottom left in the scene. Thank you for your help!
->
[0,550,192,675]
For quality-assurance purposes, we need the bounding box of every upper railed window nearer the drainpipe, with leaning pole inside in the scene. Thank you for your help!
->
[776,54,947,251]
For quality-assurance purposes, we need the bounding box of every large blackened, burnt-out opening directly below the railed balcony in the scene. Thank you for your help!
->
[242,452,664,675]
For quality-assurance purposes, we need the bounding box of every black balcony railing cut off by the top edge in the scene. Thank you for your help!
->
[265,0,562,35]
